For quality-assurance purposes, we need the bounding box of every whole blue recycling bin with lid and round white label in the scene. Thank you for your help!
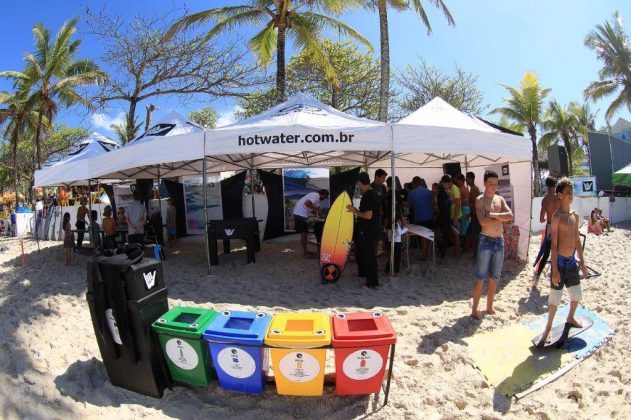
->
[203,311,272,393]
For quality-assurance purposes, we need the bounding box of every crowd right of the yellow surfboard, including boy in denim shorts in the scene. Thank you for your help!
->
[336,169,513,302]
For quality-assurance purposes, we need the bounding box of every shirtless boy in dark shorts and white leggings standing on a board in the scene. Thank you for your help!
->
[537,178,588,347]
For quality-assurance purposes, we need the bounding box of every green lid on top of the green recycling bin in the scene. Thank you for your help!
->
[151,306,217,339]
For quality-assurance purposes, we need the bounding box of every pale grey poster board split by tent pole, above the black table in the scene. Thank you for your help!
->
[182,174,223,235]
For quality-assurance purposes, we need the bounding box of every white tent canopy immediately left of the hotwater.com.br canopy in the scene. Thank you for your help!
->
[90,112,204,179]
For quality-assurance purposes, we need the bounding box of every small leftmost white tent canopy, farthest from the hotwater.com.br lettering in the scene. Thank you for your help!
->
[35,132,120,187]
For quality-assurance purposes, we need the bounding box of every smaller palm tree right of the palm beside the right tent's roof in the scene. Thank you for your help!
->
[539,100,578,175]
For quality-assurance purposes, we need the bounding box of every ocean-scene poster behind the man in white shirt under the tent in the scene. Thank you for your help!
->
[283,168,330,232]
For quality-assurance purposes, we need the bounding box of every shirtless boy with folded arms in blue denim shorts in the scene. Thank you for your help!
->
[471,171,513,319]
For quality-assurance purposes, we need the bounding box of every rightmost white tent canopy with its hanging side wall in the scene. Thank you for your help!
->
[370,97,532,260]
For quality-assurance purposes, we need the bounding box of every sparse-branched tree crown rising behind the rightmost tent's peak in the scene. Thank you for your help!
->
[397,59,484,115]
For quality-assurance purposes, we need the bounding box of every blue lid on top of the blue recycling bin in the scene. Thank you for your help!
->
[203,311,272,345]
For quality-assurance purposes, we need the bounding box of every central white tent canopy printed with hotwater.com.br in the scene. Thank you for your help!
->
[205,94,392,172]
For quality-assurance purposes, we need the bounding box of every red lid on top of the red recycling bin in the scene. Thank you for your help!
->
[332,311,397,347]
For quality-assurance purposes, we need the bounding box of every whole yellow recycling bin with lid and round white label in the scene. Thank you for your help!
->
[265,312,331,396]
